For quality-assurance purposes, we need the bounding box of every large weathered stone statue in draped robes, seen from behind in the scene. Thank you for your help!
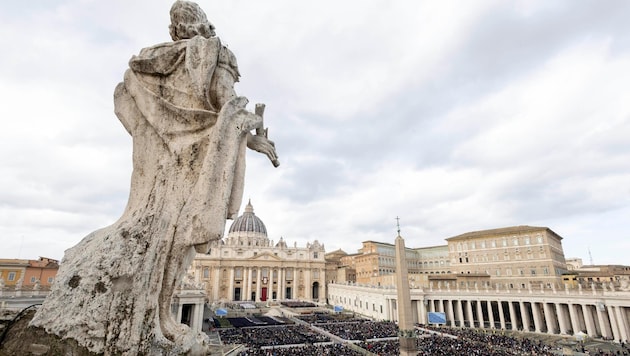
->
[31,1,279,355]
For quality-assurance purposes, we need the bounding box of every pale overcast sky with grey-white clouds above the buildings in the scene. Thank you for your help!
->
[0,0,630,264]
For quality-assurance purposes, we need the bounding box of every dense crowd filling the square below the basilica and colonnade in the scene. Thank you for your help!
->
[219,313,630,356]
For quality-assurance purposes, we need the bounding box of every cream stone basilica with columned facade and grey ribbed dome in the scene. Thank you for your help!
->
[189,201,326,302]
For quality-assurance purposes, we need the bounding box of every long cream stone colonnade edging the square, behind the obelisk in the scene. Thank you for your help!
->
[328,284,630,342]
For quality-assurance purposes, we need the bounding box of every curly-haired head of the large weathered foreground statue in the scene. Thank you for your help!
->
[168,0,215,41]
